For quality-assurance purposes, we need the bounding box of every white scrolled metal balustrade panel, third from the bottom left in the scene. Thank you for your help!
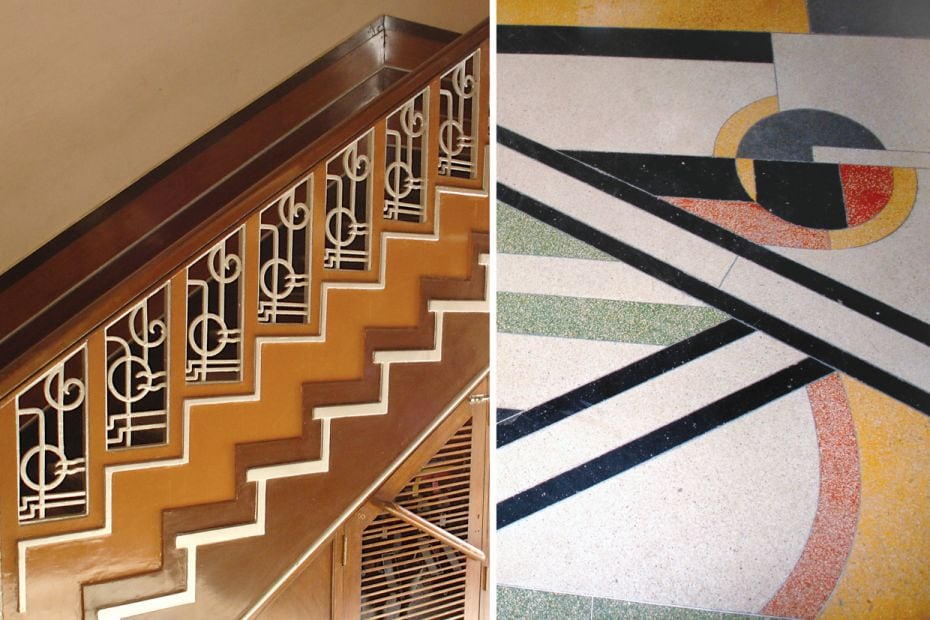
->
[184,227,244,383]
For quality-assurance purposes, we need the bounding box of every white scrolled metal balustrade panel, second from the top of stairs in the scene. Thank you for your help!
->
[384,89,429,222]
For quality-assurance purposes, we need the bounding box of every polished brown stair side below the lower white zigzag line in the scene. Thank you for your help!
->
[133,314,490,618]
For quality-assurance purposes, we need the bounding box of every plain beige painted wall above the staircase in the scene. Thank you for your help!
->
[0,0,488,272]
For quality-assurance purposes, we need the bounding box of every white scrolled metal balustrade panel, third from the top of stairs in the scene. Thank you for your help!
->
[323,130,374,270]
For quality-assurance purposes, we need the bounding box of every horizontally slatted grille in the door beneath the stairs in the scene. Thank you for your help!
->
[361,420,472,619]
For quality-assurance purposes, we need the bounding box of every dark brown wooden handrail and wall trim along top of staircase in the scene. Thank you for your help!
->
[0,18,489,397]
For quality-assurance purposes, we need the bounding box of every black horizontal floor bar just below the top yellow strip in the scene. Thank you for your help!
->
[497,25,772,63]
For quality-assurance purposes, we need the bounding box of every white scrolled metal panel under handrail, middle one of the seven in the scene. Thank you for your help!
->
[258,176,313,323]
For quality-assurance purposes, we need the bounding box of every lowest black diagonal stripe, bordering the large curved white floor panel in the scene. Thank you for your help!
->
[497,358,832,529]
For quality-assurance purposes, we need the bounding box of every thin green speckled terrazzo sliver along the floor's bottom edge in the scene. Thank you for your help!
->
[497,586,769,620]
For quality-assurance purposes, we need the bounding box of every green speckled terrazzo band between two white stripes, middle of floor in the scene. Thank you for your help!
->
[497,292,729,345]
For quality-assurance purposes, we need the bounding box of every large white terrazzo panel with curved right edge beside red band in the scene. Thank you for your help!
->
[495,390,819,612]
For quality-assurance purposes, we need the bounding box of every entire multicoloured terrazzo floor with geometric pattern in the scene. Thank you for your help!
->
[494,0,930,618]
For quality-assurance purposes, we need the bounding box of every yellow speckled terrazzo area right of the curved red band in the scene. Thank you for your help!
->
[819,377,930,619]
